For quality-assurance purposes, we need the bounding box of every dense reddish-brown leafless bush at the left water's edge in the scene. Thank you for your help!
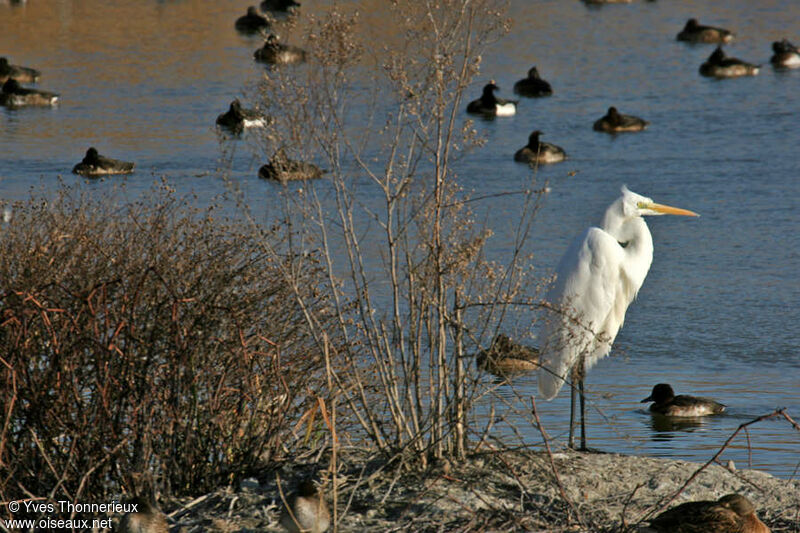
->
[0,182,338,518]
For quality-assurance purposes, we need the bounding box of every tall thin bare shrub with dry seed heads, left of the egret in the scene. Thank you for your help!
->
[244,0,543,465]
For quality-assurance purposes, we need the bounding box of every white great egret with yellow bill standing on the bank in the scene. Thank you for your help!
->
[539,186,698,449]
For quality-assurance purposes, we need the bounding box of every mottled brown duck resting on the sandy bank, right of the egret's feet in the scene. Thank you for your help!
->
[650,493,770,533]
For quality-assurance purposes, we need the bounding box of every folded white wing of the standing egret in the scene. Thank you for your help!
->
[539,227,625,400]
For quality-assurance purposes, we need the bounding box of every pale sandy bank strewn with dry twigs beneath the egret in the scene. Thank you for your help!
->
[165,450,800,532]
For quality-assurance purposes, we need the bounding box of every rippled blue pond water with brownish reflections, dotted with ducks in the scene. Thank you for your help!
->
[0,0,800,477]
